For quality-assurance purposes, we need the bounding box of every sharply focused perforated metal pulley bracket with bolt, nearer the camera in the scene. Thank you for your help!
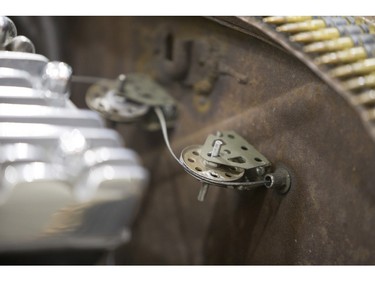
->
[180,131,291,201]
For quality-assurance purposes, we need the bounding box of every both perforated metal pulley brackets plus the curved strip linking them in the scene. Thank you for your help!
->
[86,74,291,202]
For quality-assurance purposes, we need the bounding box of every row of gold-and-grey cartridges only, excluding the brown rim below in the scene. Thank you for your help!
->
[261,16,375,138]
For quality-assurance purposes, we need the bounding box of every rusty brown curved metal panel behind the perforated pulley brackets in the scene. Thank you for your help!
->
[44,17,375,264]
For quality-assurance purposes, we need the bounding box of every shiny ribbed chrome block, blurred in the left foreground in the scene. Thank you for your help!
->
[0,17,149,253]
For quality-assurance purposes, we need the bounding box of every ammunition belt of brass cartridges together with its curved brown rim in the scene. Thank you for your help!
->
[215,16,375,141]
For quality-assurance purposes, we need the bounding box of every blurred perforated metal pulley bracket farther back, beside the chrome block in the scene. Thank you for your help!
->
[86,73,177,131]
